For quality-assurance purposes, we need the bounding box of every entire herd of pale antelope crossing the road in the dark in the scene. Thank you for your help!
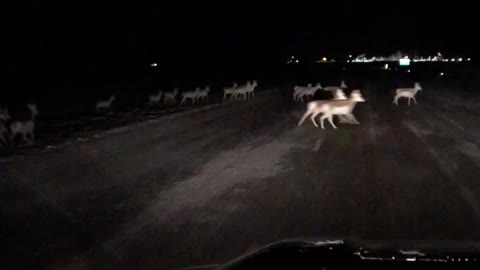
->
[0,81,422,149]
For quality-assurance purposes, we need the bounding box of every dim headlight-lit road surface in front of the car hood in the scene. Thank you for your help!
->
[0,85,480,269]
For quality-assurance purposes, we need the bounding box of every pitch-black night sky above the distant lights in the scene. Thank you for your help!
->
[1,1,478,85]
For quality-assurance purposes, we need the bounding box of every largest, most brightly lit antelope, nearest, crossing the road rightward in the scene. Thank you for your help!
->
[298,90,365,129]
